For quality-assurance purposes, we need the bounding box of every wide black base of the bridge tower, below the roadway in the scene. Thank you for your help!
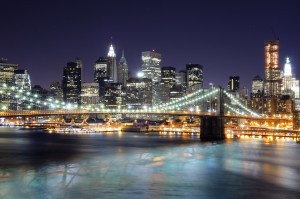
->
[200,116,225,141]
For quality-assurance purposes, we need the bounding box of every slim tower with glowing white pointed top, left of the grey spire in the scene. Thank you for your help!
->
[107,44,118,83]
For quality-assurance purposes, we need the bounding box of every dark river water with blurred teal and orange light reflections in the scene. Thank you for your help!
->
[0,128,300,199]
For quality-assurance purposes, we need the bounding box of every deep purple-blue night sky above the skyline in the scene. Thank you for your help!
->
[0,0,300,89]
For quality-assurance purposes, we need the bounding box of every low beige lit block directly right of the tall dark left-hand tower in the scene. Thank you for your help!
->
[81,82,99,105]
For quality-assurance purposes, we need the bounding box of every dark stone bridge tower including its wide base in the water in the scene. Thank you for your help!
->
[200,87,225,140]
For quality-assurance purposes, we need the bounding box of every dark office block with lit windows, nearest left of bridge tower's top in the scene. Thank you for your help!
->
[186,64,203,92]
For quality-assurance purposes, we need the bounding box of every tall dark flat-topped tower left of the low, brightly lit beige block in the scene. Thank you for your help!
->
[62,62,81,105]
